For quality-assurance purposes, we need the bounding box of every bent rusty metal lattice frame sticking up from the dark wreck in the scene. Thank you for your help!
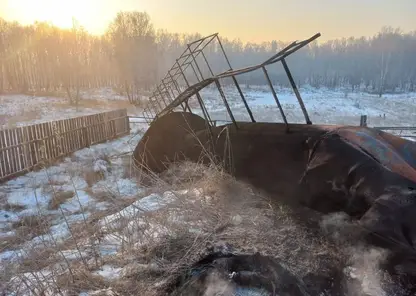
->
[137,33,321,128]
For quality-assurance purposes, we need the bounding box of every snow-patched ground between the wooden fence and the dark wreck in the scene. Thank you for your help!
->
[0,118,150,295]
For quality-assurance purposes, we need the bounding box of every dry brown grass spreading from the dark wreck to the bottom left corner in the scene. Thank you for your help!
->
[3,154,342,295]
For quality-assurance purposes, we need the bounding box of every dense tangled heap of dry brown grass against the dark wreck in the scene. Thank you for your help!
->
[97,163,342,295]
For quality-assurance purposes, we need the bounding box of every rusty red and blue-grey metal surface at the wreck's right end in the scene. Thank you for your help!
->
[335,127,416,182]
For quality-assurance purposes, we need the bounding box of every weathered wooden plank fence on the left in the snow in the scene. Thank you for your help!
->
[0,109,130,181]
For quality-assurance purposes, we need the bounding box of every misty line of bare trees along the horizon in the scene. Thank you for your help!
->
[0,12,416,102]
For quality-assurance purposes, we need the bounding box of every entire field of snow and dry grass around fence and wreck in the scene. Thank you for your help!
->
[0,87,416,295]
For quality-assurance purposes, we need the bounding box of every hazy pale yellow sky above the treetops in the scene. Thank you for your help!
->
[0,0,416,41]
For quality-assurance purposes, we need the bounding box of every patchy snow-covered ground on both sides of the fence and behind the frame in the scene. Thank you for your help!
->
[0,87,416,296]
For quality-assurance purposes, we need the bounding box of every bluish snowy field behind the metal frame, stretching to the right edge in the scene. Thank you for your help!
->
[193,86,416,126]
